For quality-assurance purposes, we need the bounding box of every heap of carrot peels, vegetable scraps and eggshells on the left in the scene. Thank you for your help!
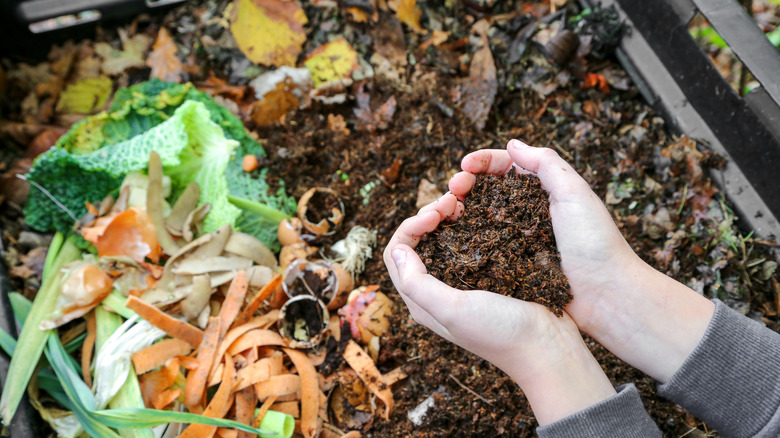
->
[3,97,398,438]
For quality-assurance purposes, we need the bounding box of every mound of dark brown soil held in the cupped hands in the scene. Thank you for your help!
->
[416,169,572,316]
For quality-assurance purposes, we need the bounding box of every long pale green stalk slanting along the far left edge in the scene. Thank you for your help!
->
[0,235,81,424]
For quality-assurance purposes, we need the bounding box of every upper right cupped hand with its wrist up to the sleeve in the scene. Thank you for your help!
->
[449,140,714,382]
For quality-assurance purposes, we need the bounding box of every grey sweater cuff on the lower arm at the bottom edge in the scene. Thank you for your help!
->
[536,383,661,438]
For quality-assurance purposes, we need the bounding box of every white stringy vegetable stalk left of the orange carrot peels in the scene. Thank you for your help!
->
[93,315,165,409]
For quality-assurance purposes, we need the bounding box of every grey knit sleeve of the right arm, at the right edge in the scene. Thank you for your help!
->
[658,300,780,438]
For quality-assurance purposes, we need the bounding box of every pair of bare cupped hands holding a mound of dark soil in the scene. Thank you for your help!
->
[384,140,713,425]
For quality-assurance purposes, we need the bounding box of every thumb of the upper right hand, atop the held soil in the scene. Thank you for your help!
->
[507,140,591,201]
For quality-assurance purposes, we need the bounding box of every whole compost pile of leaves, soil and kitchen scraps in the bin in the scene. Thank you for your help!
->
[0,0,780,437]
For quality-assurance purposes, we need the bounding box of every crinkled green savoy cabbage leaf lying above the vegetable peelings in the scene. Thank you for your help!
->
[25,79,295,248]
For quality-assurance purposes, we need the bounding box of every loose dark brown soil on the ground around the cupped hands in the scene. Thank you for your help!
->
[0,1,780,437]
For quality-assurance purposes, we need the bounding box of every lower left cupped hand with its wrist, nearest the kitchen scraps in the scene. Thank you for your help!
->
[384,194,615,424]
